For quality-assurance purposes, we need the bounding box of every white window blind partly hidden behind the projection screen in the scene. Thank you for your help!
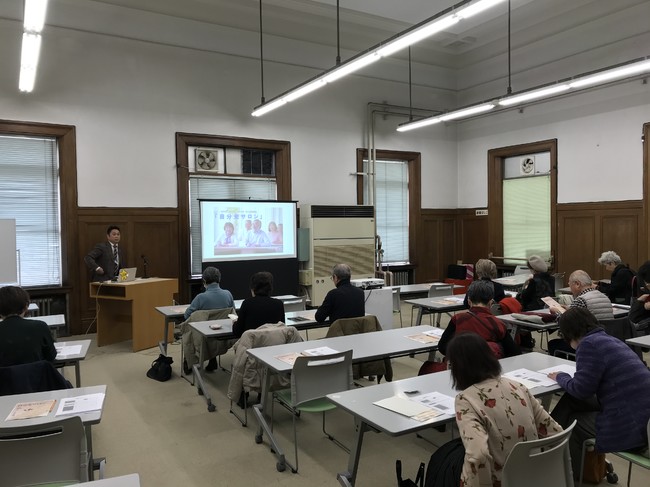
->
[189,176,277,275]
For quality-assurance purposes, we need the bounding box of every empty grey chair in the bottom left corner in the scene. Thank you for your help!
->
[0,416,89,485]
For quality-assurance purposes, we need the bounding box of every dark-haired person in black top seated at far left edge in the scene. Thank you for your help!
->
[0,286,56,367]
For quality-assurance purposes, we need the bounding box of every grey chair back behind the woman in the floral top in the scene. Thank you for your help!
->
[501,421,576,487]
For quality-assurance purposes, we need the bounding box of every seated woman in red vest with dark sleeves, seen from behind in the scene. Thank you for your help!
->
[438,280,521,359]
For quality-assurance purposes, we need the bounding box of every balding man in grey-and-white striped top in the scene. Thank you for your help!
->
[548,270,614,355]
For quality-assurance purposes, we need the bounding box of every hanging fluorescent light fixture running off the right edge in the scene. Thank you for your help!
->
[397,56,650,132]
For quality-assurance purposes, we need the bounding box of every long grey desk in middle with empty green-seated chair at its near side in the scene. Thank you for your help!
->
[248,326,438,472]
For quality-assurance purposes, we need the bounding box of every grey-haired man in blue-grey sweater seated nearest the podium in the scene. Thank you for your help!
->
[181,266,235,374]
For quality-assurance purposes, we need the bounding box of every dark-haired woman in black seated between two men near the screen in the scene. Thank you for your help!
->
[232,272,284,338]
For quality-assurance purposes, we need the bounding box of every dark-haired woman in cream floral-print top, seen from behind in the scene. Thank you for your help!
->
[433,333,562,487]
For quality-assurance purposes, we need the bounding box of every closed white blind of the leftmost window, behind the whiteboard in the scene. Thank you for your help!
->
[0,136,62,286]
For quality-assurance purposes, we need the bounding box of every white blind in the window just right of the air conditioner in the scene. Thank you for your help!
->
[363,160,409,264]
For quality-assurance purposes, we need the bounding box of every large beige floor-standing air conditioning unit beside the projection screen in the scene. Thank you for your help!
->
[300,205,375,306]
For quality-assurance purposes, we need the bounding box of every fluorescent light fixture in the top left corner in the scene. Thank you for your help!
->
[18,0,48,93]
